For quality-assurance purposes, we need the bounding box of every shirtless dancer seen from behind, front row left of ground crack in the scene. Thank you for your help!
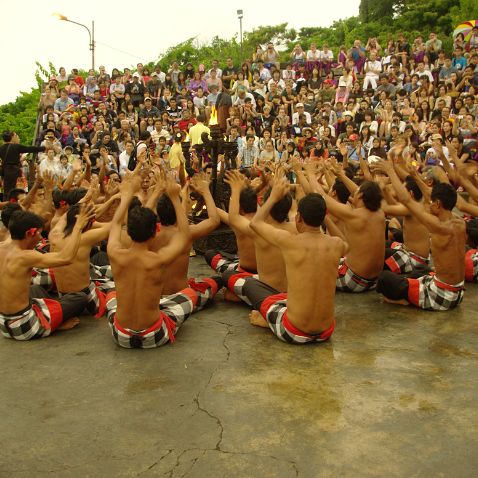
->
[106,174,222,348]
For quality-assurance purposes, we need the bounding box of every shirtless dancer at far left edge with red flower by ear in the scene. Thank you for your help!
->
[0,205,94,340]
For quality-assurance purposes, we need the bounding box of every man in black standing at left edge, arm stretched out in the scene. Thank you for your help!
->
[0,131,46,199]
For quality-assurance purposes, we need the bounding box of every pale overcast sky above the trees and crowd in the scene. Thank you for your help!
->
[0,0,360,104]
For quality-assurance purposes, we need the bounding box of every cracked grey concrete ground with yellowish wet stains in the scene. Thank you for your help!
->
[0,258,478,478]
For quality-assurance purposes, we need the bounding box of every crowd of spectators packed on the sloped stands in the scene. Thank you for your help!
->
[30,28,478,182]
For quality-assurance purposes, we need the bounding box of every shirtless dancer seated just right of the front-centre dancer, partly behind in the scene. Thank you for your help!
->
[305,163,385,292]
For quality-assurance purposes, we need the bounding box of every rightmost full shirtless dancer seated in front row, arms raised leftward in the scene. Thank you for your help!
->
[377,161,466,310]
